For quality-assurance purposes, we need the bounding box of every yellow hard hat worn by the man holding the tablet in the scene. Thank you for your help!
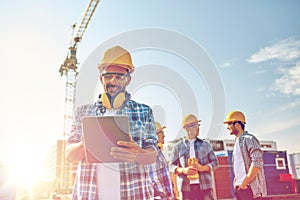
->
[98,46,134,73]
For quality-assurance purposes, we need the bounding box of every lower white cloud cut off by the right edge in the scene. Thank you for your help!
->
[273,63,300,96]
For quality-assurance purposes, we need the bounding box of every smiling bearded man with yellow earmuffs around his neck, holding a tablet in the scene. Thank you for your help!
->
[66,46,158,200]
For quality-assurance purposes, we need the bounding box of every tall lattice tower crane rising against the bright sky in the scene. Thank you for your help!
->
[59,0,99,136]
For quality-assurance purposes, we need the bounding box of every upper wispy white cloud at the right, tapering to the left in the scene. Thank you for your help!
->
[247,38,300,63]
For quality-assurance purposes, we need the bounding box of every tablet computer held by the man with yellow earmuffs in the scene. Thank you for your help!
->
[82,115,130,163]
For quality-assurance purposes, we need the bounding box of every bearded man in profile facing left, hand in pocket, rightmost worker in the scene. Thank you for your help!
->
[224,111,266,200]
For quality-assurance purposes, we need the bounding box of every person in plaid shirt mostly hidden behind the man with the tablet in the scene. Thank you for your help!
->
[149,122,174,200]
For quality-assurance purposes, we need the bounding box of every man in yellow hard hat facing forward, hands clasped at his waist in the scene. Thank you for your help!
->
[170,114,219,200]
